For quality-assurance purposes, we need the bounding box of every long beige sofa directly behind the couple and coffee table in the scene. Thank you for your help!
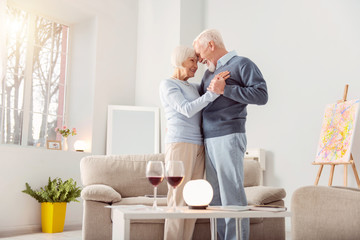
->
[80,154,286,240]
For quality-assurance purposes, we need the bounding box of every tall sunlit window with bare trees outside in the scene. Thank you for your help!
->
[0,6,69,147]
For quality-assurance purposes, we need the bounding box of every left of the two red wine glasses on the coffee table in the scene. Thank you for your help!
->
[146,161,164,210]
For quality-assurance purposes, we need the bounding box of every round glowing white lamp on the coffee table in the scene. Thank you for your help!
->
[183,179,214,209]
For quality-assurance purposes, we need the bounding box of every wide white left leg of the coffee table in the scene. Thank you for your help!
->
[112,209,130,240]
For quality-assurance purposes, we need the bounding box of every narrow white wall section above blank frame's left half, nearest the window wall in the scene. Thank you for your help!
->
[90,0,138,154]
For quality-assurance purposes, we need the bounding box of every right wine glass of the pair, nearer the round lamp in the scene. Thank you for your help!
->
[165,161,185,212]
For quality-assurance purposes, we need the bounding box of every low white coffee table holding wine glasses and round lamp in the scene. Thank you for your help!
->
[107,205,291,240]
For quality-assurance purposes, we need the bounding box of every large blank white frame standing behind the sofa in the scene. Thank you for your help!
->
[106,105,160,155]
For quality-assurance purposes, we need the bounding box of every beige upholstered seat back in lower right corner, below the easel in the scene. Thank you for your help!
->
[291,186,360,240]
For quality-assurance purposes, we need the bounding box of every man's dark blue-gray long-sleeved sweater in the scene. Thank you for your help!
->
[200,52,268,138]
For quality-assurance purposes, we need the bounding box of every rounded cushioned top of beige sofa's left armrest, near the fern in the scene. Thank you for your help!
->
[81,184,121,203]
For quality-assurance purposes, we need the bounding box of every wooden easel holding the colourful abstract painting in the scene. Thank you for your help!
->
[312,84,360,188]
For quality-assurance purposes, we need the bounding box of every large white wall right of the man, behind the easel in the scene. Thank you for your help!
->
[205,0,360,215]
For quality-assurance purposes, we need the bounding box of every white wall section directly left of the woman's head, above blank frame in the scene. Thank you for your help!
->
[135,0,180,107]
